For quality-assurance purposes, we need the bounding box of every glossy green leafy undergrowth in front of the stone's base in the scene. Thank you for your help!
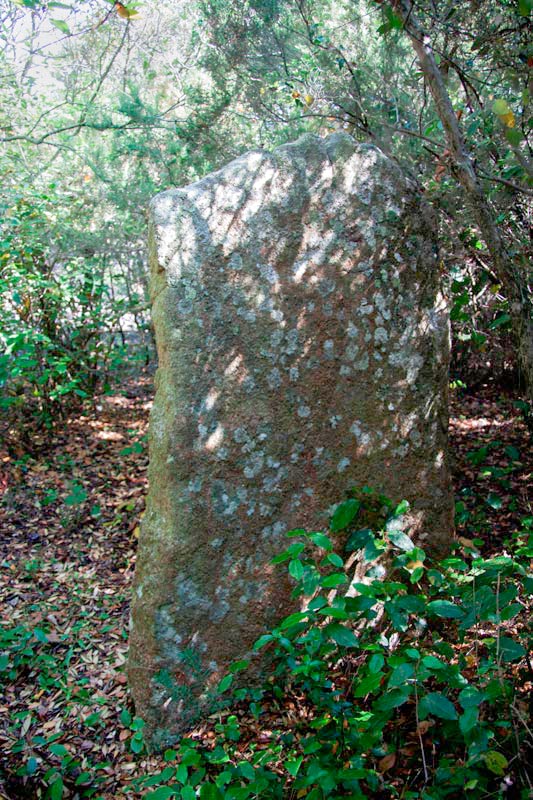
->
[0,489,533,800]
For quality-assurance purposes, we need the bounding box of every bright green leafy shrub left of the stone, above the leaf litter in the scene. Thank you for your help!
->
[0,186,143,424]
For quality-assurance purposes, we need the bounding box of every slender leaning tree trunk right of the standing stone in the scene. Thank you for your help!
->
[394,0,533,402]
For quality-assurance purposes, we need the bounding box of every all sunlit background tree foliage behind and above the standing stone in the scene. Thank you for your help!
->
[0,0,533,432]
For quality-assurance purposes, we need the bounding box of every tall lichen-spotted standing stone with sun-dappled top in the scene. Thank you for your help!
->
[129,134,452,746]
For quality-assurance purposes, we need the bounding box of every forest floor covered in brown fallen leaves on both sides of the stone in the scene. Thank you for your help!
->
[0,378,533,800]
